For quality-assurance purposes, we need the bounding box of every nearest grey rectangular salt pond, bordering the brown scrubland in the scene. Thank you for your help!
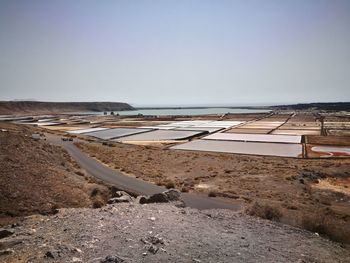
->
[171,140,303,157]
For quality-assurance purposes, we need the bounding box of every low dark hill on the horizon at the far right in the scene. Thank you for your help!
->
[271,102,350,111]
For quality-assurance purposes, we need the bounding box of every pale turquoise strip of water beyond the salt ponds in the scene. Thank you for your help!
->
[85,108,270,116]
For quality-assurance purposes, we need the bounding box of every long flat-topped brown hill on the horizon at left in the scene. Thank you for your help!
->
[0,101,134,114]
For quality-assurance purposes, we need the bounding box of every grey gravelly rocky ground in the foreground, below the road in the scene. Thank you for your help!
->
[0,192,350,263]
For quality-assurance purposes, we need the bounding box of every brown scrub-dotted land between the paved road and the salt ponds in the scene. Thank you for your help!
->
[77,143,350,242]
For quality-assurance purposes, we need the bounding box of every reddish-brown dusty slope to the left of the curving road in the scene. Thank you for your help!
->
[0,123,113,224]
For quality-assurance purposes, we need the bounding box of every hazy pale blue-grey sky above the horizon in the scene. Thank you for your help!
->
[0,0,350,106]
